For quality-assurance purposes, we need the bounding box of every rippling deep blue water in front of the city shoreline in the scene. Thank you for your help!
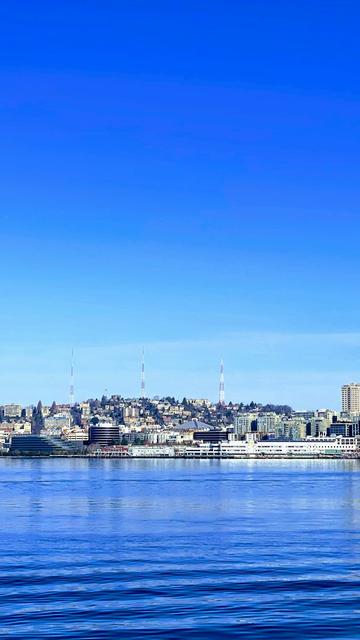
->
[0,459,360,640]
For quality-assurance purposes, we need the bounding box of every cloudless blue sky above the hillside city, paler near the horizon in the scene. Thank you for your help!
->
[0,0,360,408]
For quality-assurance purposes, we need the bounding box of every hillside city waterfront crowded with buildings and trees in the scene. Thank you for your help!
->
[0,384,360,457]
